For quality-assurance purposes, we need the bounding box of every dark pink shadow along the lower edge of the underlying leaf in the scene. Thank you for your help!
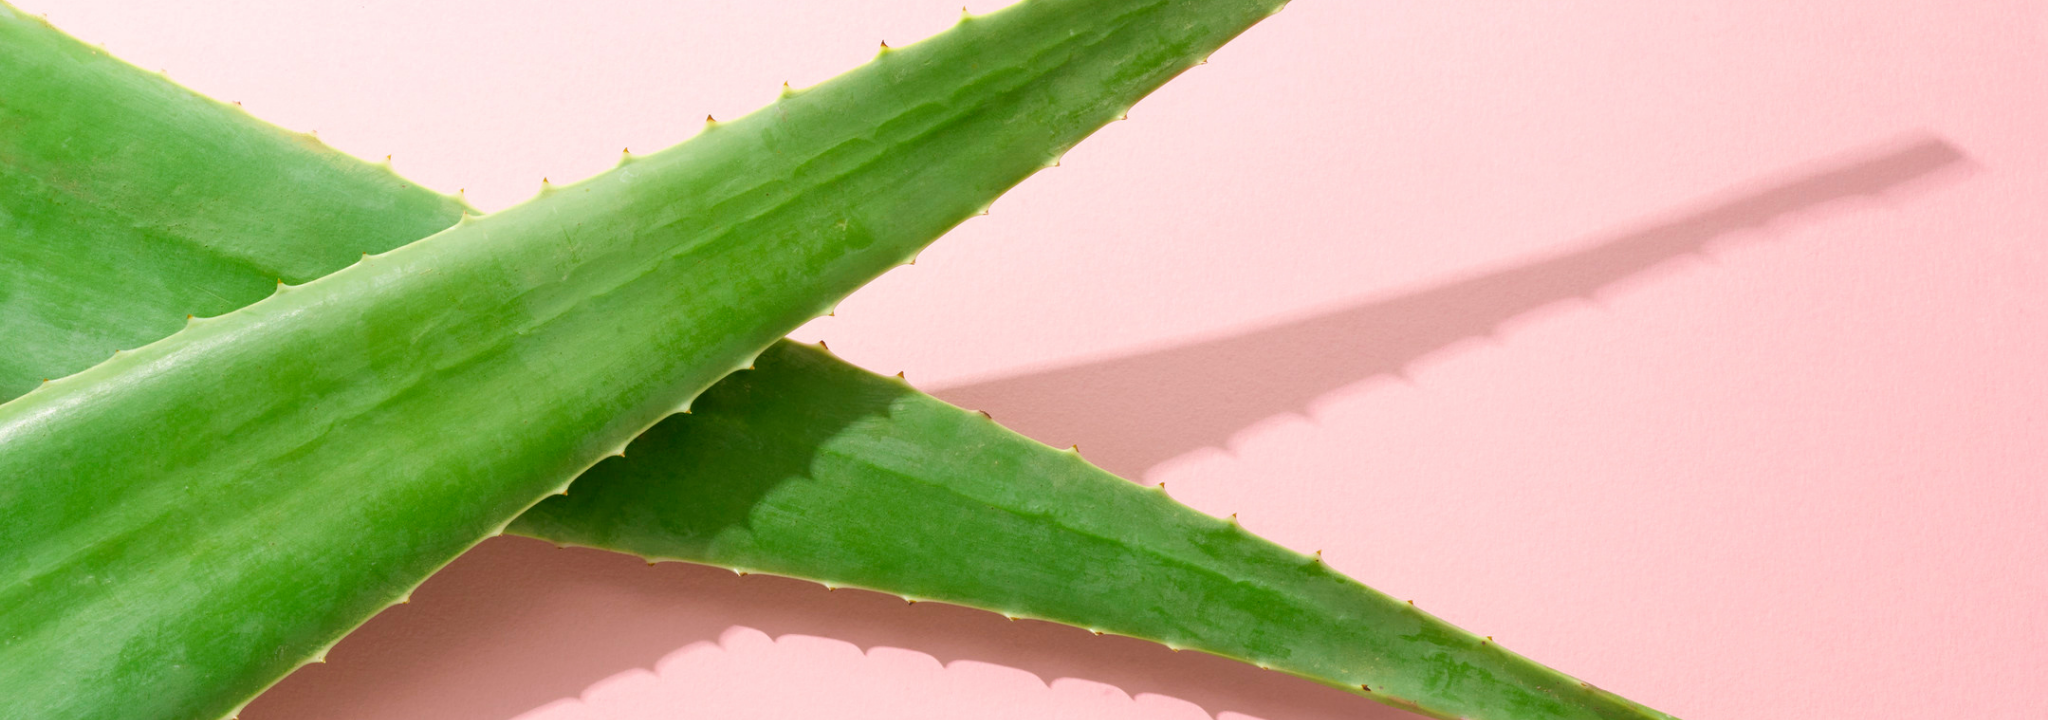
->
[242,538,1411,720]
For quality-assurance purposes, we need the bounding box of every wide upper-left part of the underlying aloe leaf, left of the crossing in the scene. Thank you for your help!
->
[0,11,467,401]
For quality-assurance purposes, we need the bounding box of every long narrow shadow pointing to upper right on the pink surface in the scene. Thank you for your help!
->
[936,137,1968,479]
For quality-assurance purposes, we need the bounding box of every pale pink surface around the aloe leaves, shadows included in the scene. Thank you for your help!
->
[20,0,2048,720]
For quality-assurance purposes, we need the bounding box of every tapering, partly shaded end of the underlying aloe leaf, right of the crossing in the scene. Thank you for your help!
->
[508,342,1669,720]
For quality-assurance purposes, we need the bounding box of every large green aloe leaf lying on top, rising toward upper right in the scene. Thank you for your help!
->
[0,0,1278,718]
